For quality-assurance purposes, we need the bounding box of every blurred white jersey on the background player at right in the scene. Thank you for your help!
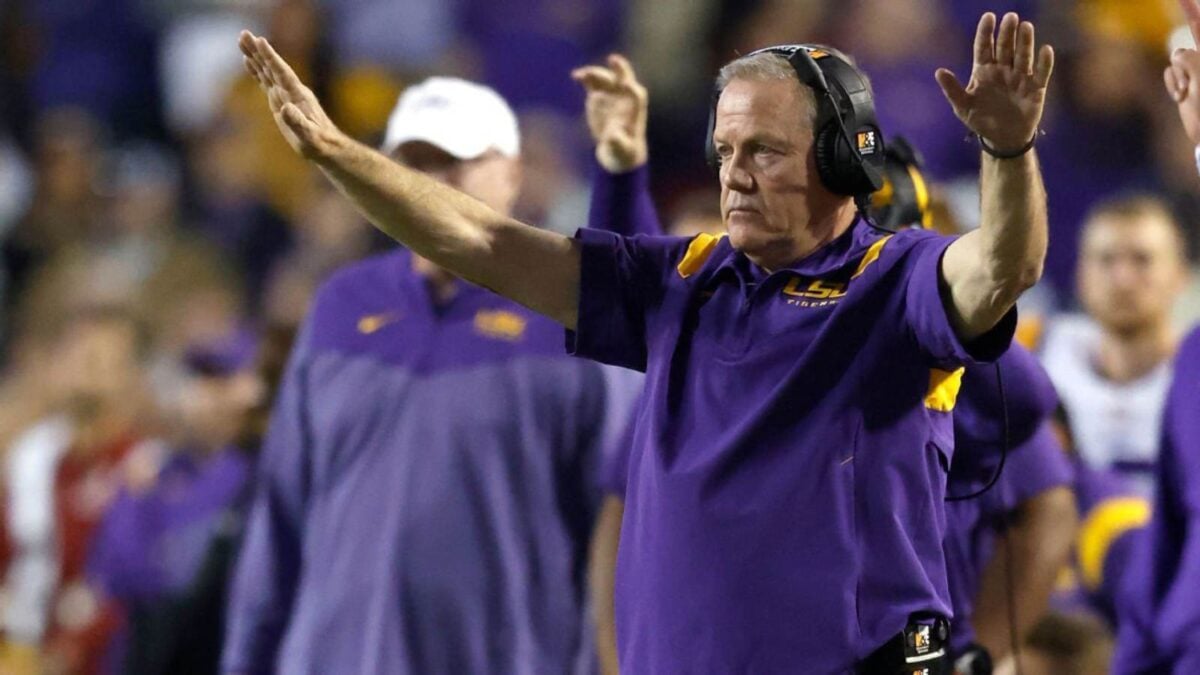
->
[1042,315,1171,496]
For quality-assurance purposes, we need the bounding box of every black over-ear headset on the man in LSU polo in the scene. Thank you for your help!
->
[704,44,884,199]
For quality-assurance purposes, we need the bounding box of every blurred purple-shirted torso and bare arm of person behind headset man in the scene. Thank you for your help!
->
[944,355,1078,675]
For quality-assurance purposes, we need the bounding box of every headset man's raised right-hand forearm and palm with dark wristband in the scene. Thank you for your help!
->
[937,12,1054,341]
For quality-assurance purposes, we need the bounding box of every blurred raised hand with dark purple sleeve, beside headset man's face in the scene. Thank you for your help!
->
[571,54,664,237]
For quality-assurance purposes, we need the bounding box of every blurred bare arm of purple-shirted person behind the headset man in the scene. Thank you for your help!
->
[972,485,1079,664]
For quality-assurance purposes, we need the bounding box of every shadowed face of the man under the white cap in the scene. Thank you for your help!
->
[392,141,521,215]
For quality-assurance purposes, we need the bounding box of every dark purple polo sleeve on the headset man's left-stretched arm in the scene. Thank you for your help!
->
[566,228,688,371]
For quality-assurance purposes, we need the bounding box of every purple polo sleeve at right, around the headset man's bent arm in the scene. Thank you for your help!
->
[905,237,1016,368]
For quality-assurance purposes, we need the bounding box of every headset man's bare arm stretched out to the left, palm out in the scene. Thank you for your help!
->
[239,31,580,328]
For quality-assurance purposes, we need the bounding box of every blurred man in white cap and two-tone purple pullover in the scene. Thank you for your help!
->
[222,78,638,674]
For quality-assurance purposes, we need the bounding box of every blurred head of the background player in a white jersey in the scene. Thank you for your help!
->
[1079,215,1187,334]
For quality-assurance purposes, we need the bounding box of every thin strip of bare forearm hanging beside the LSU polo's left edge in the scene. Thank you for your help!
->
[588,494,625,675]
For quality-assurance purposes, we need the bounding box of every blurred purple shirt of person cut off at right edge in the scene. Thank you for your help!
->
[1114,328,1200,675]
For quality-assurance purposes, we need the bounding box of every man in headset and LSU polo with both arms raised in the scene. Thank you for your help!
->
[240,14,1052,673]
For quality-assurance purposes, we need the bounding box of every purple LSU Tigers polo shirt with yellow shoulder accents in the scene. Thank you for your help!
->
[569,212,1015,673]
